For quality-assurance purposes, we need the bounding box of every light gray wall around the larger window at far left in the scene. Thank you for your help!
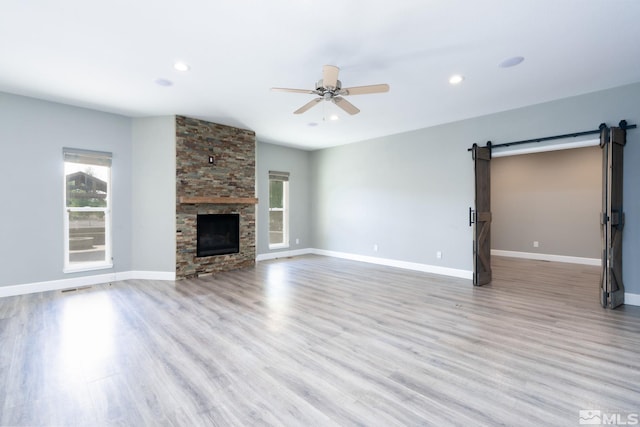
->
[0,93,132,286]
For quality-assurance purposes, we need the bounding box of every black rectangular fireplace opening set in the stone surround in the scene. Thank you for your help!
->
[196,214,240,257]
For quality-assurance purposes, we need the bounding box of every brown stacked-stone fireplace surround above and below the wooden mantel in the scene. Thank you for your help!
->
[176,116,256,279]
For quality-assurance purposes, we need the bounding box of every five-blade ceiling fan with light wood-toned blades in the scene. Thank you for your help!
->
[271,65,389,115]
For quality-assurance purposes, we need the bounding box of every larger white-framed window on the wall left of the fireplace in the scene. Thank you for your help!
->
[63,148,113,273]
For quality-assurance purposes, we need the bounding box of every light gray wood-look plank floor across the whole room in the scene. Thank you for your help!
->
[0,256,640,426]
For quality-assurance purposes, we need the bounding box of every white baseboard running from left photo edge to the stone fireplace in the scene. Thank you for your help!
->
[0,271,176,298]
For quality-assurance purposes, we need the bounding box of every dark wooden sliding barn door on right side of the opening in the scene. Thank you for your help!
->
[600,125,627,308]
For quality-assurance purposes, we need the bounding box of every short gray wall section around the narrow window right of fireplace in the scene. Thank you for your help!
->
[256,142,313,255]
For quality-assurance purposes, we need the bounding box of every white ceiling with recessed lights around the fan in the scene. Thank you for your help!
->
[0,0,640,149]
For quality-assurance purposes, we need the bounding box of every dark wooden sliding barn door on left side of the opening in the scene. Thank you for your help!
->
[469,143,491,286]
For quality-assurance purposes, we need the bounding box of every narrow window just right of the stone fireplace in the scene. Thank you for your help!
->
[269,171,289,249]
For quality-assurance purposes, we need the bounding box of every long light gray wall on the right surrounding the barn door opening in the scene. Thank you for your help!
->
[311,84,640,293]
